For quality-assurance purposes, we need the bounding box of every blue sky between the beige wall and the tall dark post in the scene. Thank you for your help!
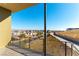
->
[12,4,44,30]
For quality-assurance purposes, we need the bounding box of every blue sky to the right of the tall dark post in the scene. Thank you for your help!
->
[47,3,79,30]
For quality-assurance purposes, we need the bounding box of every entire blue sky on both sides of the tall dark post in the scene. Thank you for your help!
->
[12,3,79,30]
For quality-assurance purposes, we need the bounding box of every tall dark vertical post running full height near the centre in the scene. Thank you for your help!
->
[43,3,46,56]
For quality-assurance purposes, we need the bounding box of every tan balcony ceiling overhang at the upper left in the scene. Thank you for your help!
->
[0,3,35,12]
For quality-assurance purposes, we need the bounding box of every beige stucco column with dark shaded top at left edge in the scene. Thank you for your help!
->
[0,7,11,48]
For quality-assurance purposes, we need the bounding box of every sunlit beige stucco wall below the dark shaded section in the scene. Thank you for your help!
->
[0,16,11,48]
